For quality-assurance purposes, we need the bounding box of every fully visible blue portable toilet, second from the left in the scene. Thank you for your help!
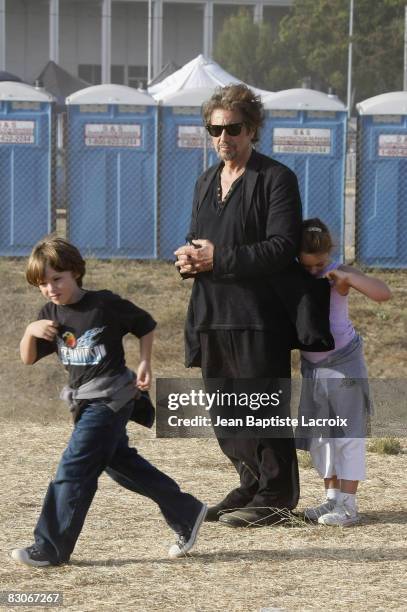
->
[66,84,157,259]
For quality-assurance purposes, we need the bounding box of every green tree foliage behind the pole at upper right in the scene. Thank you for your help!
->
[216,0,406,107]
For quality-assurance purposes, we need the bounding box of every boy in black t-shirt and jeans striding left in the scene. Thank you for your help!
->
[11,238,206,567]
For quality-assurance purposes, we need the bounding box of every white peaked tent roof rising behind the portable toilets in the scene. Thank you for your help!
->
[148,55,270,100]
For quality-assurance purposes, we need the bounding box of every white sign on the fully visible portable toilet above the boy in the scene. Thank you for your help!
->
[85,123,141,147]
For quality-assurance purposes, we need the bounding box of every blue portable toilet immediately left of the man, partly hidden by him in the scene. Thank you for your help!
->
[159,87,218,259]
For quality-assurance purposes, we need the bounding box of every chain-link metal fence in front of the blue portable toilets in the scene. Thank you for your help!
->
[0,103,407,268]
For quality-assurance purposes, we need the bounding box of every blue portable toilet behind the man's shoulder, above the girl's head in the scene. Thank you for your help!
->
[259,88,347,259]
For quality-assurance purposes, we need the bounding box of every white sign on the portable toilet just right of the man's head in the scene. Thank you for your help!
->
[273,128,331,155]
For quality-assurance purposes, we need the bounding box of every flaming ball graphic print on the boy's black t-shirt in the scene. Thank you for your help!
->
[57,327,106,366]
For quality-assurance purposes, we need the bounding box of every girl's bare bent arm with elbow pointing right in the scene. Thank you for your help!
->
[326,265,391,302]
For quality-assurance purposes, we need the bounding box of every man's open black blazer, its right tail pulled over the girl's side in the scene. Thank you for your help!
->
[184,151,334,367]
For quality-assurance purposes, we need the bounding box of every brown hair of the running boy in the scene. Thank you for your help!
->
[25,236,86,287]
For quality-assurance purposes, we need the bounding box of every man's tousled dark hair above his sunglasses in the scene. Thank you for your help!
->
[202,83,264,142]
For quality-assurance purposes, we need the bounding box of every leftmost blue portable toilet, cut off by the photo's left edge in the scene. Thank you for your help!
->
[0,81,55,256]
